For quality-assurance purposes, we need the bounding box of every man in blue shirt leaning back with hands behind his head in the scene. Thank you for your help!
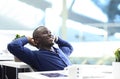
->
[8,26,73,71]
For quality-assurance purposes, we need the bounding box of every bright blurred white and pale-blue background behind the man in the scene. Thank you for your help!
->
[0,0,120,64]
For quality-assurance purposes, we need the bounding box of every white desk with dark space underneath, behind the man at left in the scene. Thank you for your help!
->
[0,61,30,79]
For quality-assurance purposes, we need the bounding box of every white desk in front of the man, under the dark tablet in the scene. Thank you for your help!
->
[18,66,113,79]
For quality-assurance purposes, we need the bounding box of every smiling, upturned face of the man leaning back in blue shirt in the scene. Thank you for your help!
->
[38,27,54,47]
